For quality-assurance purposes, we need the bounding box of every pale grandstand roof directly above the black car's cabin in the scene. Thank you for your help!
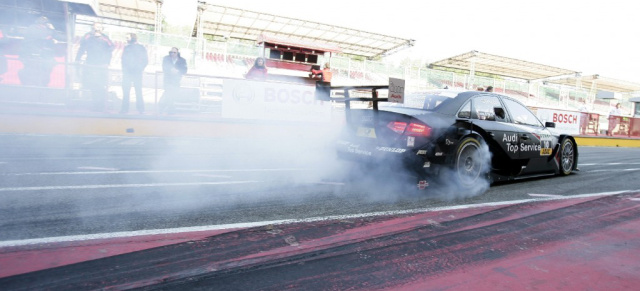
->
[429,51,578,81]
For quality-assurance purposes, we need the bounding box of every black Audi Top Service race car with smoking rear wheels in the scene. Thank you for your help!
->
[330,88,578,189]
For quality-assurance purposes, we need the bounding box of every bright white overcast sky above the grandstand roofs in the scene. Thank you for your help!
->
[164,0,640,83]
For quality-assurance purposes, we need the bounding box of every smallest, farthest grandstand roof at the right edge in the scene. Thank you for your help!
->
[548,74,640,93]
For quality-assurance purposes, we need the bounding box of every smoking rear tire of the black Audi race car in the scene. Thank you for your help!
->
[453,137,487,188]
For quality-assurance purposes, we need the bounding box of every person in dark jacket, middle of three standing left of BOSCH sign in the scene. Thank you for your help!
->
[120,33,149,114]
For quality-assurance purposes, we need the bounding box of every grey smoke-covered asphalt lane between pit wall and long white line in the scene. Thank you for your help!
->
[0,135,640,241]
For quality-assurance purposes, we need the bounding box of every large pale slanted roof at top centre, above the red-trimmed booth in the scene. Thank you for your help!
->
[202,4,414,59]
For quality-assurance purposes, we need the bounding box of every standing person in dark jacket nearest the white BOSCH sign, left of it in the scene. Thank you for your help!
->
[160,47,187,113]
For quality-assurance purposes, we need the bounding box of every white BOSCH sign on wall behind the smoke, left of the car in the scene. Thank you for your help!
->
[222,80,331,122]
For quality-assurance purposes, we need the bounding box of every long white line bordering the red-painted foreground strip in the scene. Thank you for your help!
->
[0,189,640,248]
